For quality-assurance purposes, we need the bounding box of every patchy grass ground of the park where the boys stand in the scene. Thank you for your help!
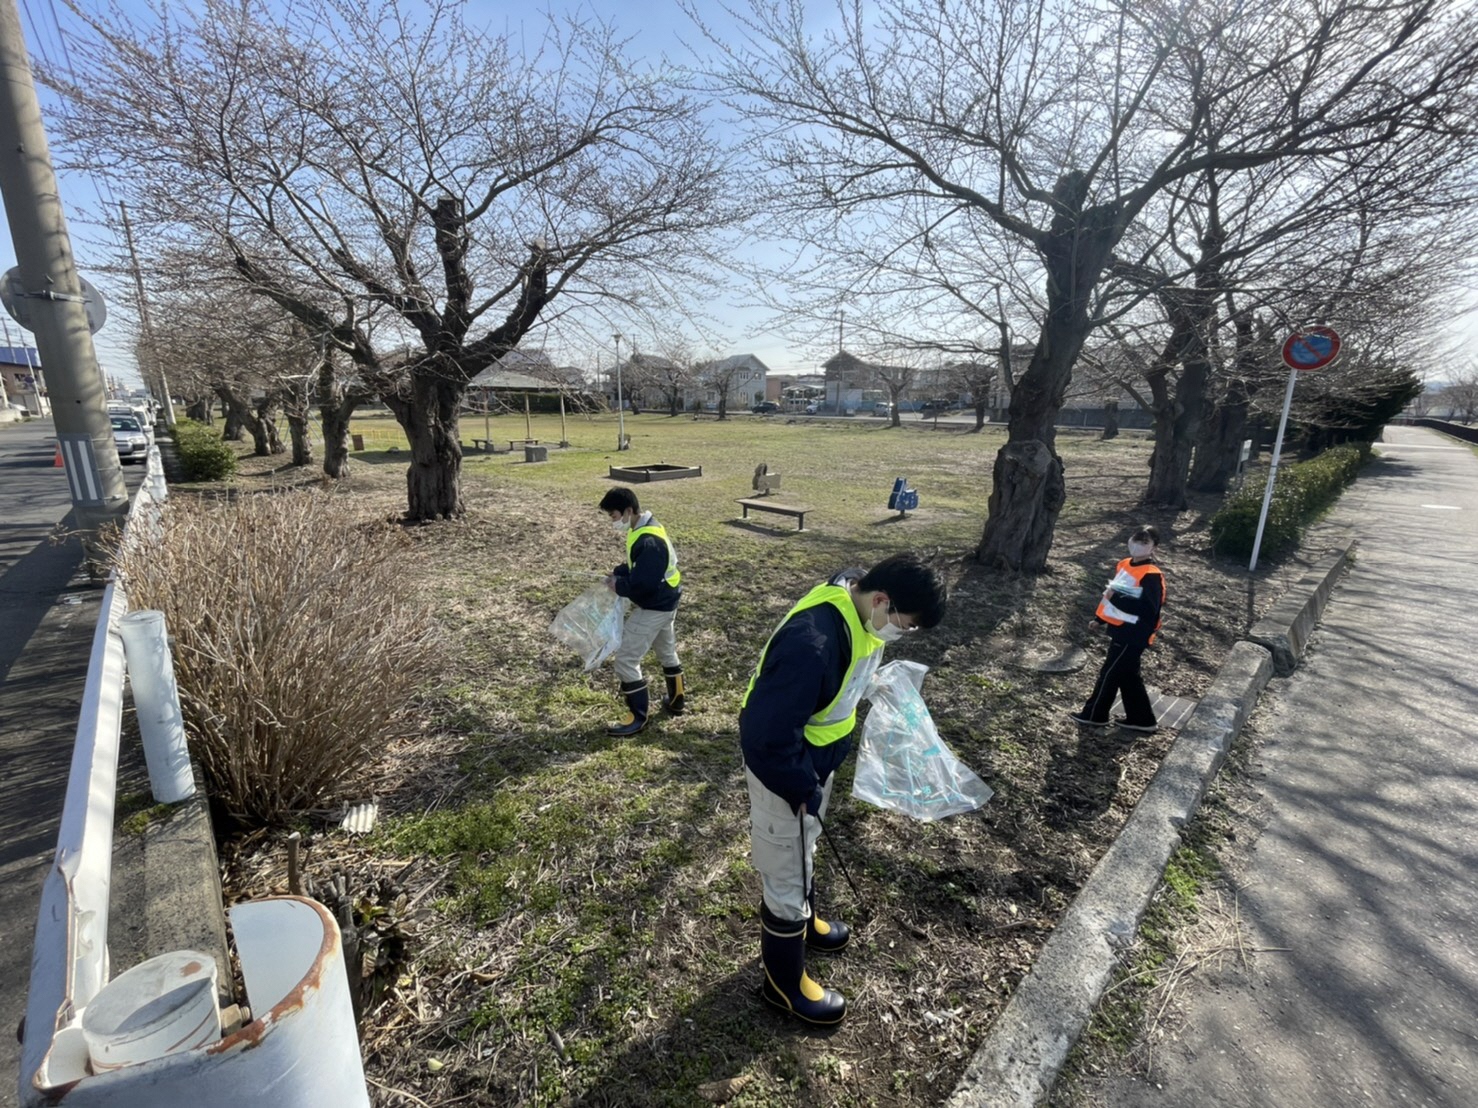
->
[202,414,1324,1105]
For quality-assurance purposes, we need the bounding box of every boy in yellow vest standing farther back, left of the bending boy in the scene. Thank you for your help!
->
[600,489,687,736]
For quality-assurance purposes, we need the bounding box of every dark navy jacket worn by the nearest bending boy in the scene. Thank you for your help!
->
[739,570,862,813]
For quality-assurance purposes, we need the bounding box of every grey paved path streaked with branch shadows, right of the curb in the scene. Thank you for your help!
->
[1101,427,1478,1108]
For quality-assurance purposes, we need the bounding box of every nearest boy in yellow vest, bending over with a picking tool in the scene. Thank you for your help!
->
[739,554,946,1024]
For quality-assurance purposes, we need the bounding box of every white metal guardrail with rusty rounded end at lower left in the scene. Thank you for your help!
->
[19,448,370,1108]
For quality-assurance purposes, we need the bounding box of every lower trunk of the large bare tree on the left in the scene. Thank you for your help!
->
[387,365,467,521]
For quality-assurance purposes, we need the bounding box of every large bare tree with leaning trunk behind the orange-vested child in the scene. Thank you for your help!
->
[711,0,1478,570]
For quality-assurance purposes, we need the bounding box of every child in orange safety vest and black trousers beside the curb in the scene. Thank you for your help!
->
[1069,527,1165,733]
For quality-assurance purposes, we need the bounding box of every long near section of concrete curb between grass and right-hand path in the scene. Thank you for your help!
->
[946,643,1273,1108]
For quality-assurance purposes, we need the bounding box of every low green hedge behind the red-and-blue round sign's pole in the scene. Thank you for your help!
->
[1210,443,1370,558]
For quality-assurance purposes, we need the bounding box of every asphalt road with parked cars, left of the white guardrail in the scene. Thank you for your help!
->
[0,420,142,1108]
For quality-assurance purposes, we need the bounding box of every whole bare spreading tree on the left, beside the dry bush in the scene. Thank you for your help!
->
[47,0,732,520]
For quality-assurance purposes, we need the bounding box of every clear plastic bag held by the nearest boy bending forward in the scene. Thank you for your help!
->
[851,662,995,821]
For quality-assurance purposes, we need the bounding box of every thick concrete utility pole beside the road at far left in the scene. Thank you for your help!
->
[0,0,129,527]
